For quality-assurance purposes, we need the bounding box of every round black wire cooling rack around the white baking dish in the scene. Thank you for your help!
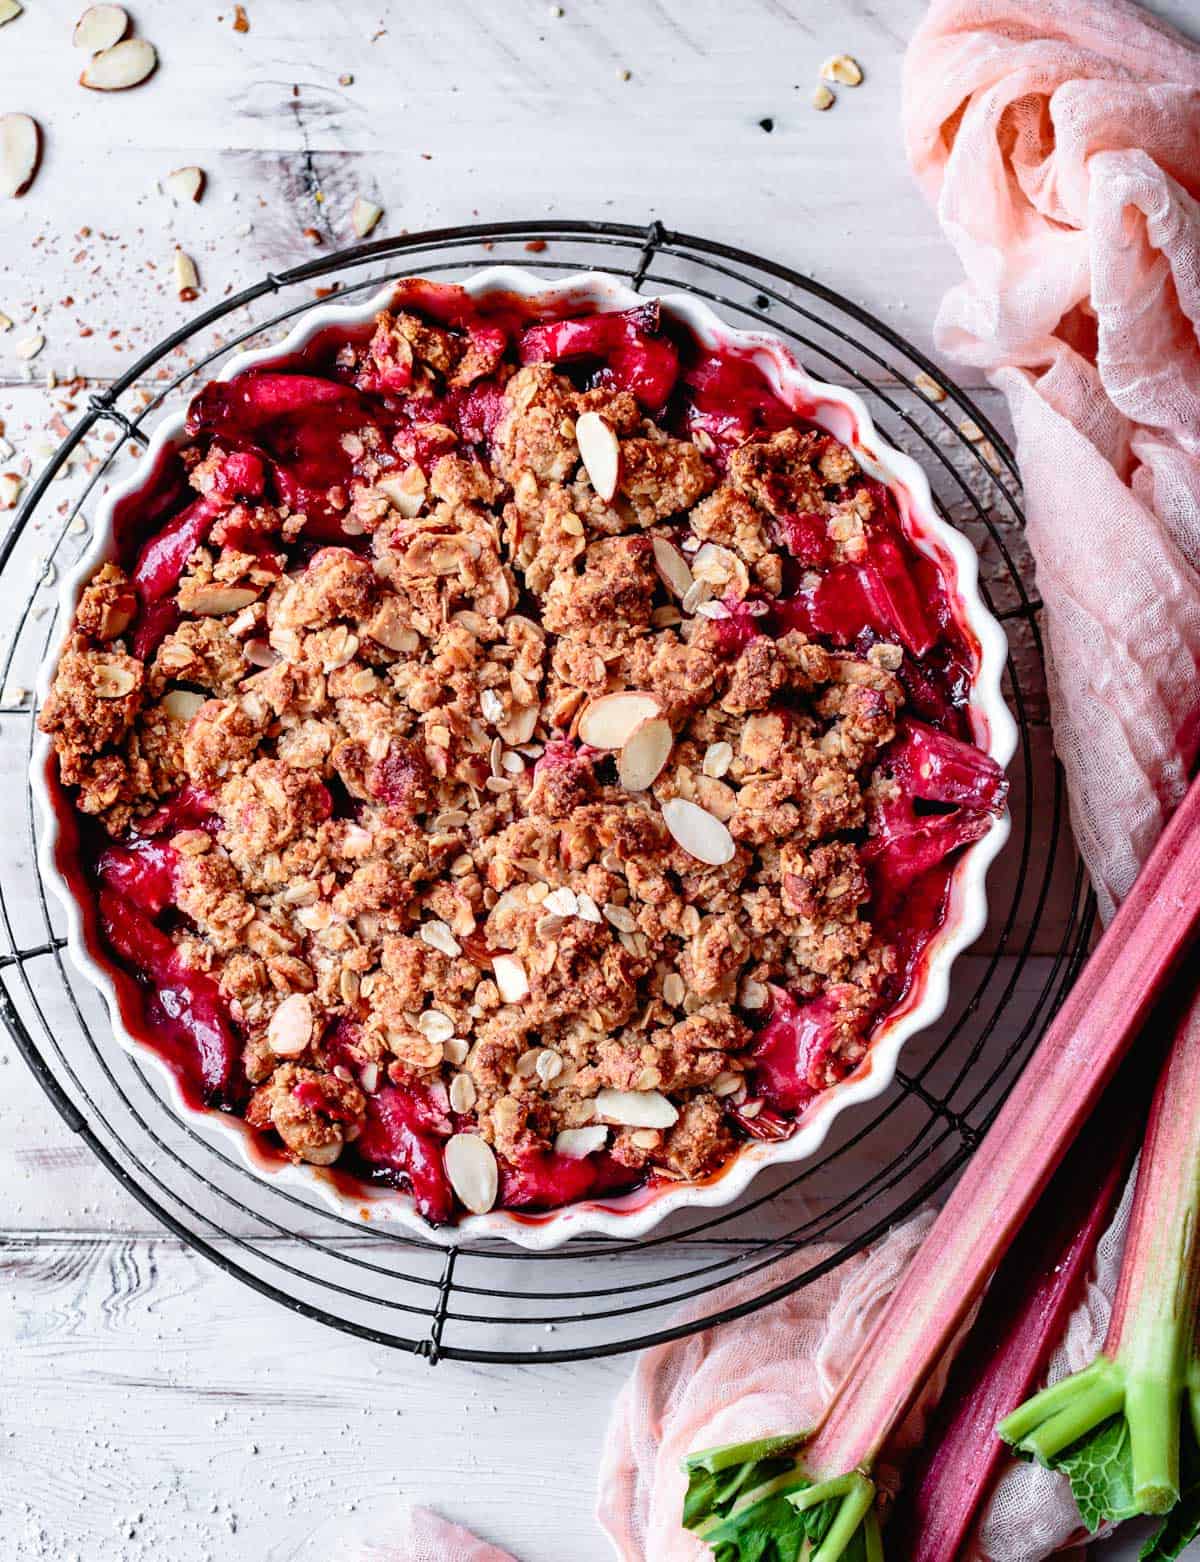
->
[0,222,1094,1362]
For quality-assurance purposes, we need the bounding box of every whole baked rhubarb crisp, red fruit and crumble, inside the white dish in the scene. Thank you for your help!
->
[41,283,1005,1223]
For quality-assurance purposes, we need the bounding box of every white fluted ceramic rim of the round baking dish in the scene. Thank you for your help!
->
[31,266,1017,1251]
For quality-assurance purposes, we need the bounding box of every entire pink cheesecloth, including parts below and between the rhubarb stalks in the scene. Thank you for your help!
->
[365,0,1200,1562]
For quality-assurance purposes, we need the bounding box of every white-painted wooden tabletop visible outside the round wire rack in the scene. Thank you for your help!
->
[0,0,1191,1562]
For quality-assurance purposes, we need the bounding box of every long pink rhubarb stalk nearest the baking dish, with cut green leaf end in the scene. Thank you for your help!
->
[684,781,1200,1562]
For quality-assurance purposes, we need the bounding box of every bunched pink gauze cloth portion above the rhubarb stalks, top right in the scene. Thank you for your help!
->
[905,0,1200,917]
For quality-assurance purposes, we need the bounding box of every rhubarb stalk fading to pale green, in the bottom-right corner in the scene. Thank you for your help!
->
[1000,998,1200,1531]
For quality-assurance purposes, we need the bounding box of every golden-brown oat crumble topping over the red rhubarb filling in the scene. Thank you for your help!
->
[42,314,903,1199]
